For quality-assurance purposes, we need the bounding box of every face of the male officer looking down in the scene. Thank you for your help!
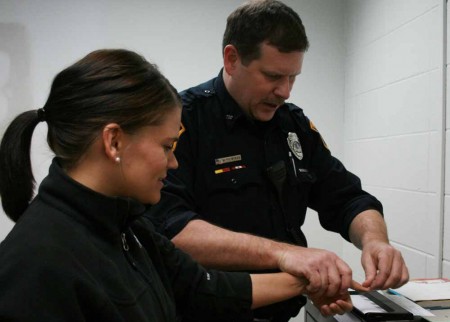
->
[227,43,304,121]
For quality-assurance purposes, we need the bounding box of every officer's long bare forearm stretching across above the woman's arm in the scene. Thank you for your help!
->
[172,220,288,270]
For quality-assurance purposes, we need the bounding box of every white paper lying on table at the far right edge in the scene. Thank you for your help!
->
[395,278,450,301]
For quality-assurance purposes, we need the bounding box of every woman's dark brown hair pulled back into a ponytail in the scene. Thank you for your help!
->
[0,49,181,221]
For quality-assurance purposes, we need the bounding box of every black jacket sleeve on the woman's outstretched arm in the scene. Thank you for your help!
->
[134,218,252,321]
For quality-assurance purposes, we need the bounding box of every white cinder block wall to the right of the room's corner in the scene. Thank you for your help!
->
[344,0,442,279]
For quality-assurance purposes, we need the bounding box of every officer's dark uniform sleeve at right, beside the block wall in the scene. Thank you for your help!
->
[298,112,383,241]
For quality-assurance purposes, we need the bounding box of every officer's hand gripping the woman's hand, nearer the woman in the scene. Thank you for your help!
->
[278,245,352,297]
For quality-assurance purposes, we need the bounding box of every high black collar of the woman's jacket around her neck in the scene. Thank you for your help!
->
[38,158,147,235]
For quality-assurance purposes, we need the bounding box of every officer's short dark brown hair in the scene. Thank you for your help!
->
[222,0,309,64]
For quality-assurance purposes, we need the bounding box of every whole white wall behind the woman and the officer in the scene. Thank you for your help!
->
[0,0,450,321]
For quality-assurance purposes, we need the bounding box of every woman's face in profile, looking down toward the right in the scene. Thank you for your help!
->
[119,107,181,204]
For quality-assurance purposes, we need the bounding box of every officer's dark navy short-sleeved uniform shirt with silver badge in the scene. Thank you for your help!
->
[150,72,382,320]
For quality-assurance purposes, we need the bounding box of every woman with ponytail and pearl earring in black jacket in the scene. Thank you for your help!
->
[0,49,351,322]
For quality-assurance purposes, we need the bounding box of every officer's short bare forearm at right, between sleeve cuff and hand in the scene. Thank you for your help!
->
[349,210,389,249]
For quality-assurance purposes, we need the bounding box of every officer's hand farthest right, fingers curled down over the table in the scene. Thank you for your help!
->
[361,240,409,290]
